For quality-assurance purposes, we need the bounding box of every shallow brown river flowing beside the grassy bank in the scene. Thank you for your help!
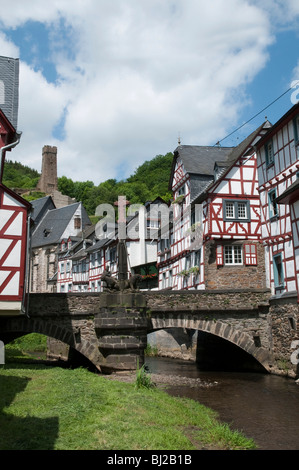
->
[145,357,299,450]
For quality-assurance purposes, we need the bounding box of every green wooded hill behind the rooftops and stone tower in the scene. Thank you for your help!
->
[3,152,173,215]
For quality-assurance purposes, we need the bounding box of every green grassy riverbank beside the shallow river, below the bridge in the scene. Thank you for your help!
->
[0,334,255,450]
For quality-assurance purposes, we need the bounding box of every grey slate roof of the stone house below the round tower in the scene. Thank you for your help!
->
[32,202,90,248]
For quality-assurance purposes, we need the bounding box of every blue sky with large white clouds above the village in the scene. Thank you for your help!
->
[0,0,299,184]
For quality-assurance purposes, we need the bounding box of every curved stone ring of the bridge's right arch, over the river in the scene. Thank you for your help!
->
[149,315,272,372]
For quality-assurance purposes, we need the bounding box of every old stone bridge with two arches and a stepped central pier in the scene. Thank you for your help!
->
[0,289,298,377]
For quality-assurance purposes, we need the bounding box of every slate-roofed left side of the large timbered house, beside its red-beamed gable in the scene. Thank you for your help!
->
[158,145,236,290]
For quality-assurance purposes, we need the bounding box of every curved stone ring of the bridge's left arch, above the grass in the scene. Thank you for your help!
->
[1,317,103,372]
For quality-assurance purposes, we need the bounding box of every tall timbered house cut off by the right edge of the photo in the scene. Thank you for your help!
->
[257,104,299,302]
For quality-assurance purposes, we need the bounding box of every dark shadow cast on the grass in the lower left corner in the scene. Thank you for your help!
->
[0,375,59,450]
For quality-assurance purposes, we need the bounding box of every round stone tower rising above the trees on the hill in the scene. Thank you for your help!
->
[36,145,58,194]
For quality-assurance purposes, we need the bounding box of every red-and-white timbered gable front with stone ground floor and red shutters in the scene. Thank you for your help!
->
[195,121,271,289]
